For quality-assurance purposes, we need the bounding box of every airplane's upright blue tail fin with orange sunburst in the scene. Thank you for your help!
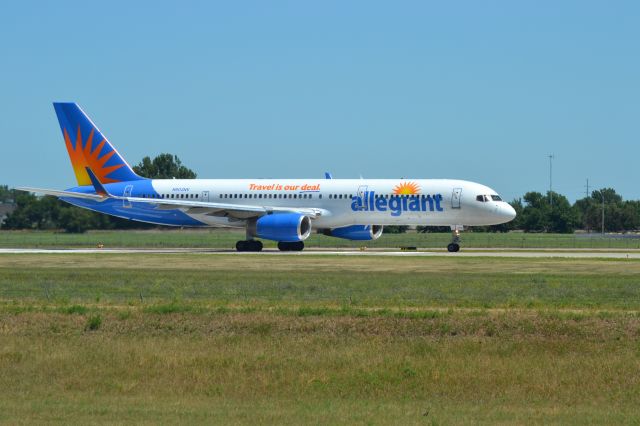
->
[53,102,144,186]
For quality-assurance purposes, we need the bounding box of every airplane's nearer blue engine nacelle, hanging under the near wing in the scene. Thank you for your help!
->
[247,213,311,242]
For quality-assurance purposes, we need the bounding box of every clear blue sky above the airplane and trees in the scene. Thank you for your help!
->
[0,0,640,201]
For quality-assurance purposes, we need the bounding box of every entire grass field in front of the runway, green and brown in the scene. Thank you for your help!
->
[0,254,640,424]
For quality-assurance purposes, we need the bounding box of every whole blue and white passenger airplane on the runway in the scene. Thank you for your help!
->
[17,102,516,252]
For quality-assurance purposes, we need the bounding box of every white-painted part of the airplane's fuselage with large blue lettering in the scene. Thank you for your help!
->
[145,179,515,229]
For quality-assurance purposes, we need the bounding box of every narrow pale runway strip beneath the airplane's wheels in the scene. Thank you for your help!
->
[0,248,640,259]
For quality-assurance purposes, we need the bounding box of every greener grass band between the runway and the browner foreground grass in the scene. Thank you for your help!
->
[0,254,640,312]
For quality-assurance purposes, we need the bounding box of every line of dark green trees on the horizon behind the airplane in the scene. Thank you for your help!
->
[0,153,640,233]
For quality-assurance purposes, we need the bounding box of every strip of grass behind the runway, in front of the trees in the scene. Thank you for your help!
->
[0,229,640,249]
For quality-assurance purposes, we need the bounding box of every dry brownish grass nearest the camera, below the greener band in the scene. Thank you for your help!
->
[0,308,640,424]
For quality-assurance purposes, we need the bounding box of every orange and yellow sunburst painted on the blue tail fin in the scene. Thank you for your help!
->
[63,126,124,186]
